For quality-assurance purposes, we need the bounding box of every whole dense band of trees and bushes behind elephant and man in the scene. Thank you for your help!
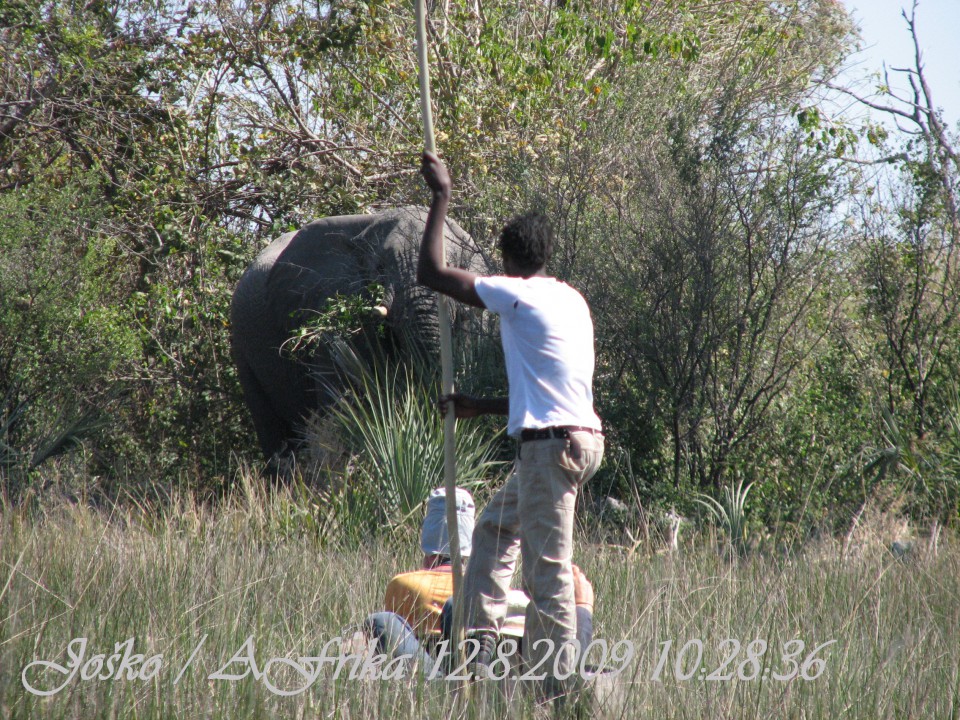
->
[0,0,960,529]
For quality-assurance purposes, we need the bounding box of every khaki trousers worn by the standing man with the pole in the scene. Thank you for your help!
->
[464,432,603,678]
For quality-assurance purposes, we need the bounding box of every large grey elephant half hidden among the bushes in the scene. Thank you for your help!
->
[230,206,488,463]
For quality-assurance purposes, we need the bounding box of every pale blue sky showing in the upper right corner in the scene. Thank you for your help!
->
[843,0,960,129]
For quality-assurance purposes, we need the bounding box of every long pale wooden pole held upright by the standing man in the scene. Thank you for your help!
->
[414,0,463,667]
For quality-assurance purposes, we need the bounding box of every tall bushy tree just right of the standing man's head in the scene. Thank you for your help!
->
[502,3,849,486]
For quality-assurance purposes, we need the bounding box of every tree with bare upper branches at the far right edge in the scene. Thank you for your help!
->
[838,3,960,520]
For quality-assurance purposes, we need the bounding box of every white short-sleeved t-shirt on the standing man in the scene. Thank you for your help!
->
[474,275,601,435]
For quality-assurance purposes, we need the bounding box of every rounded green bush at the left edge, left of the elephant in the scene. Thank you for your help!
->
[0,178,140,490]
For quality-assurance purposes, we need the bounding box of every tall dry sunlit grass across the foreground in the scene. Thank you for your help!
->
[0,476,960,719]
